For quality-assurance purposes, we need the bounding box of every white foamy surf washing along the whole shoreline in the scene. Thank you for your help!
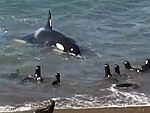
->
[0,92,150,112]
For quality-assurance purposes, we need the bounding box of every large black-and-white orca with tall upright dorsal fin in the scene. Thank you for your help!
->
[22,10,80,56]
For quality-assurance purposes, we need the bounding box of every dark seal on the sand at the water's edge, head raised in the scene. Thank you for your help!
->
[33,100,55,113]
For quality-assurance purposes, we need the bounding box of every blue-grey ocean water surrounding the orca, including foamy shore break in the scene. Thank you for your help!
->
[0,0,150,111]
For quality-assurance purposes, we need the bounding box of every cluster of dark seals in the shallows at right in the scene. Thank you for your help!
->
[105,59,150,88]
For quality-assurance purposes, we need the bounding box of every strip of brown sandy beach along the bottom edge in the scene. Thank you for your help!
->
[2,106,150,113]
